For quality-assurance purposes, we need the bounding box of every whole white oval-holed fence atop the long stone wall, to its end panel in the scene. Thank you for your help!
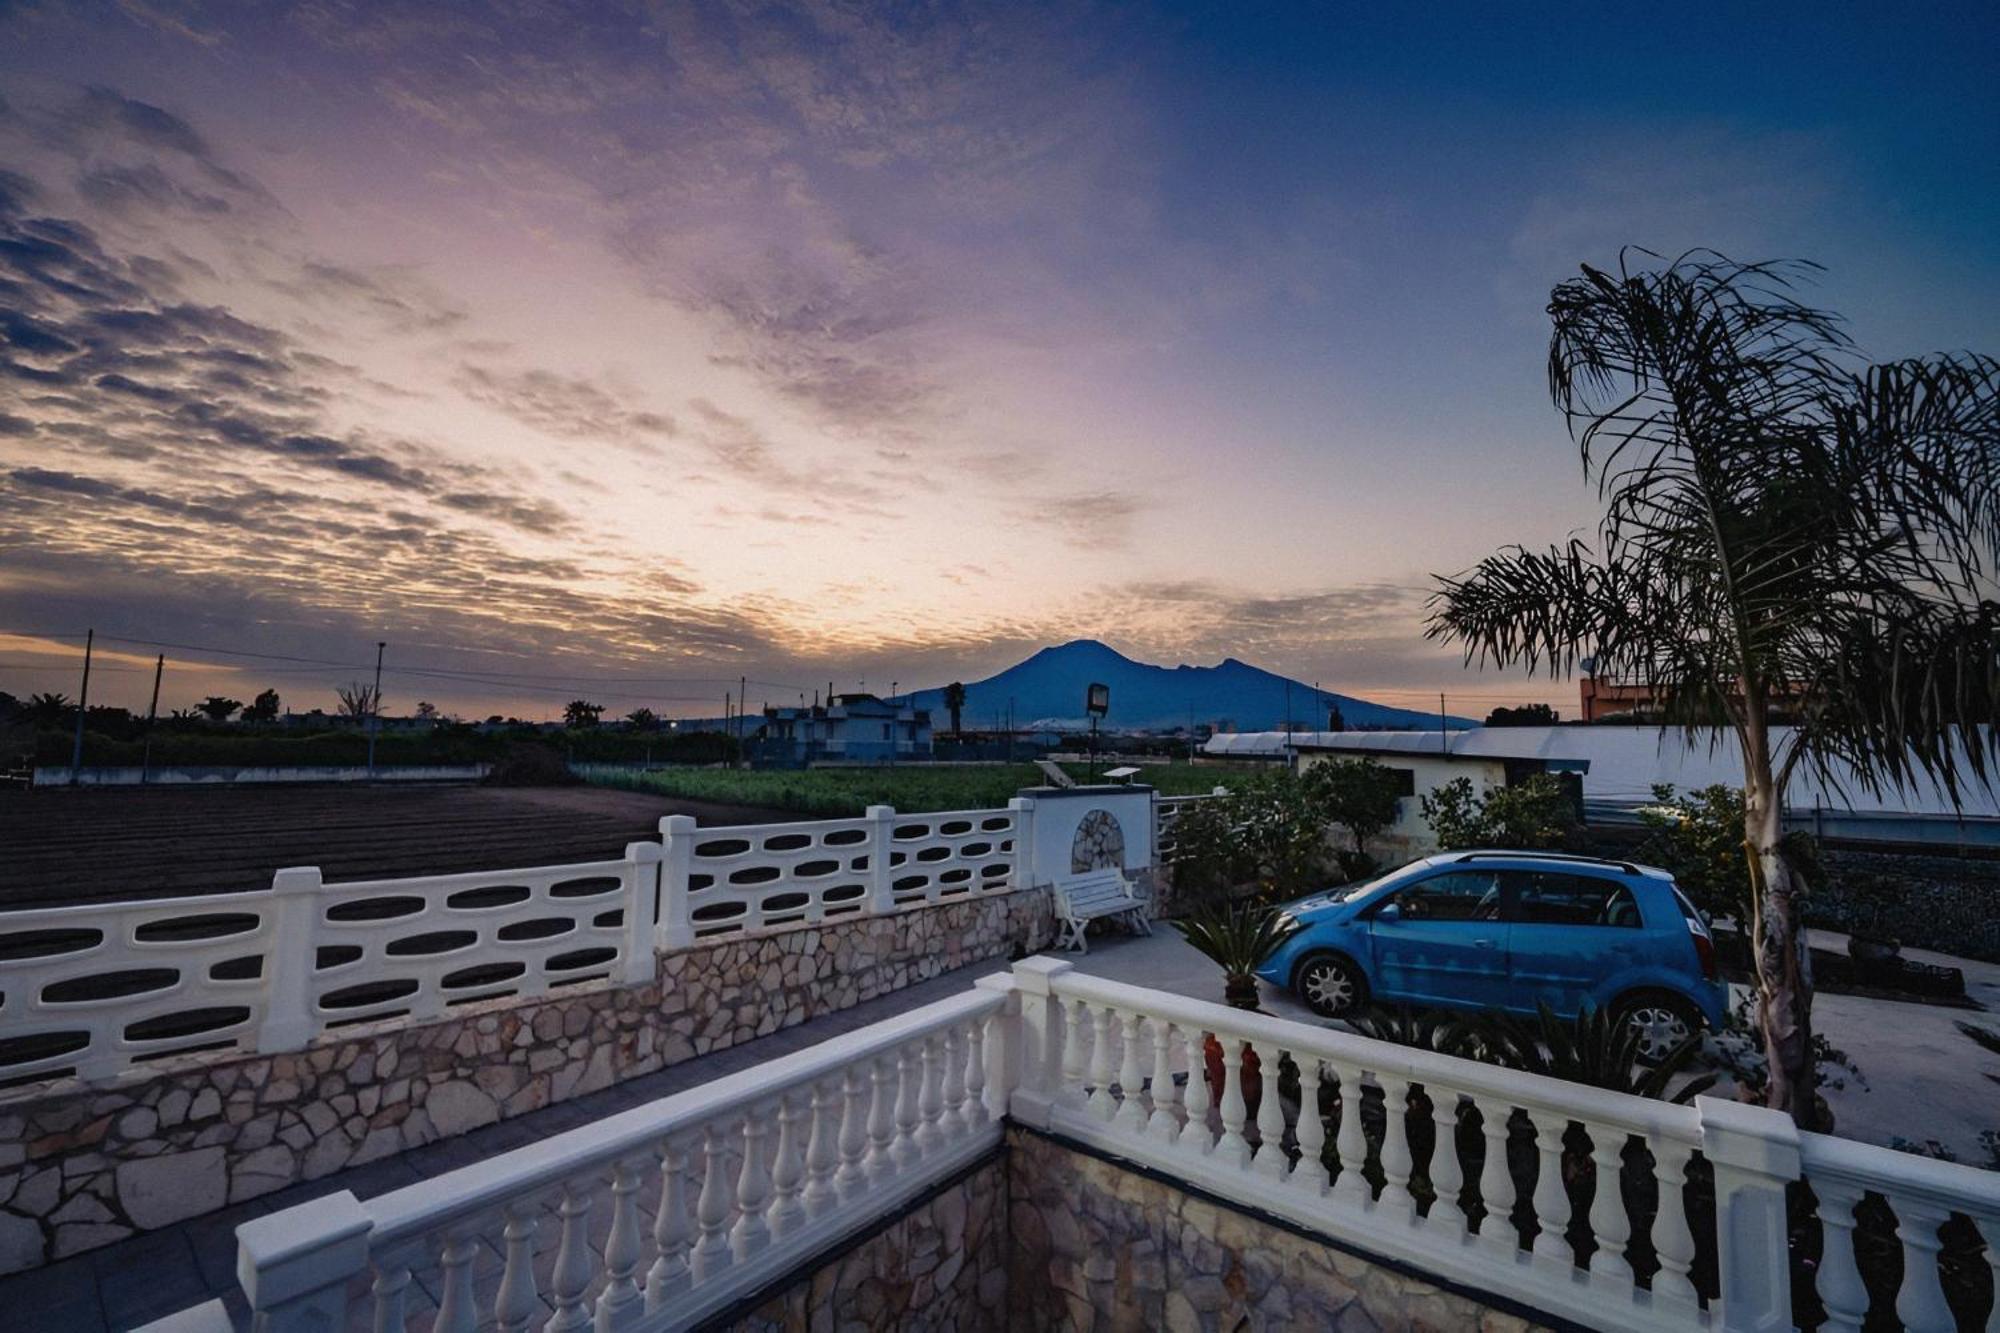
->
[0,789,1154,1083]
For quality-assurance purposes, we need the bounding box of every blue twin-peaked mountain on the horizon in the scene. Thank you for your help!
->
[910,638,1476,731]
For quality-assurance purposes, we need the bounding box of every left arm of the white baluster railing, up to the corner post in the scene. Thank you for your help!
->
[238,989,1008,1333]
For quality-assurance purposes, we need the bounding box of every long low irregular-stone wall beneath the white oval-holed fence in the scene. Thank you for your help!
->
[0,889,1052,1273]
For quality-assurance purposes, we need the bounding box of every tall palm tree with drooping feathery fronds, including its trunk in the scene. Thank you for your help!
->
[1430,250,2000,1123]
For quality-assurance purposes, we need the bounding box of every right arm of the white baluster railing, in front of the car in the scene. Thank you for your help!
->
[1012,959,2000,1329]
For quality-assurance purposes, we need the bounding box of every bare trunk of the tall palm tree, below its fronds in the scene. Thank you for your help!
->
[1744,727,1820,1129]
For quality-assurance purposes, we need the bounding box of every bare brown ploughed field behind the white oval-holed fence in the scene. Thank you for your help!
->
[0,785,786,909]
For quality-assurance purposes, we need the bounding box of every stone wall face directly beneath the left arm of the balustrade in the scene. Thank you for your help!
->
[710,1157,1022,1333]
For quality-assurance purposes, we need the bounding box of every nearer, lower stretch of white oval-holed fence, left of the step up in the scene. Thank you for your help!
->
[0,843,660,1083]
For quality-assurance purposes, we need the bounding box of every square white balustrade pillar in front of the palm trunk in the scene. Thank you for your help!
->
[1694,1097,1800,1333]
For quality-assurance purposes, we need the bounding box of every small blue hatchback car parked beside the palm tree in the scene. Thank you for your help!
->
[1258,851,1728,1059]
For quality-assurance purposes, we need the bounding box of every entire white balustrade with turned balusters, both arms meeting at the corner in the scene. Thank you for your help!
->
[158,957,2000,1333]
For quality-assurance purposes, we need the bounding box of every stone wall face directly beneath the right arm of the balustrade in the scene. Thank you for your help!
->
[1008,1129,1534,1333]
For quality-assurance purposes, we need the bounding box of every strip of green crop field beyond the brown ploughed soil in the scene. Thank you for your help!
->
[590,765,1242,817]
